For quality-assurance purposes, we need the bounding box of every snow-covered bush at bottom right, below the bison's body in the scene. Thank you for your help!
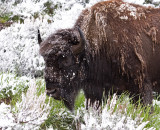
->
[81,94,154,130]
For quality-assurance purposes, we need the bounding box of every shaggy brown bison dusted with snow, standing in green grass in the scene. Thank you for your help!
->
[38,0,160,110]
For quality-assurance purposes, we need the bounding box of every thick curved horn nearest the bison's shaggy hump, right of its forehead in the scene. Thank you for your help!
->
[72,27,86,54]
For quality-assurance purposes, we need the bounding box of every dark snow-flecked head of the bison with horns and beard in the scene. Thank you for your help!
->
[38,28,86,110]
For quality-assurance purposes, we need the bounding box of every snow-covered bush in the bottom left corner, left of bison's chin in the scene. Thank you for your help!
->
[0,80,51,130]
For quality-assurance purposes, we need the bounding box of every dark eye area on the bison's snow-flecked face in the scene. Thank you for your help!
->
[59,56,74,68]
